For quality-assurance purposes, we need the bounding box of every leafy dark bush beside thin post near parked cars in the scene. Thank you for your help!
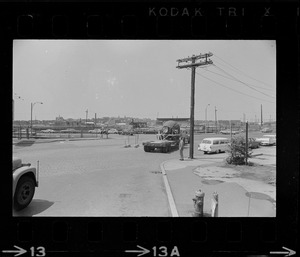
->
[226,136,251,165]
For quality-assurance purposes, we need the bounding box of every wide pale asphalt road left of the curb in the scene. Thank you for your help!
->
[13,134,274,217]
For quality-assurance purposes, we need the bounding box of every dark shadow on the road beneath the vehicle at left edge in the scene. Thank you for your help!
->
[13,199,54,217]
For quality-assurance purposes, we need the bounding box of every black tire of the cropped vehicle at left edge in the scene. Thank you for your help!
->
[14,176,35,211]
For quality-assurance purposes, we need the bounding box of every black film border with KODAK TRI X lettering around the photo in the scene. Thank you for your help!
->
[0,2,299,256]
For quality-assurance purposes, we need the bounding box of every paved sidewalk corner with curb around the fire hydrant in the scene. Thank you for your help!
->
[161,157,276,217]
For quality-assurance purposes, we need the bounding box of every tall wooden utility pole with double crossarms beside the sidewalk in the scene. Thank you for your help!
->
[176,53,213,159]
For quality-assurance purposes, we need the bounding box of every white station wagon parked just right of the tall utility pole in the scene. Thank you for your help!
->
[198,137,230,154]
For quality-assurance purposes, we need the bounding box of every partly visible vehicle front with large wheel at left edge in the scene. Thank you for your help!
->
[12,156,39,211]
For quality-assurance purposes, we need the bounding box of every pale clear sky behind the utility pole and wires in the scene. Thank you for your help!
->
[13,40,276,121]
